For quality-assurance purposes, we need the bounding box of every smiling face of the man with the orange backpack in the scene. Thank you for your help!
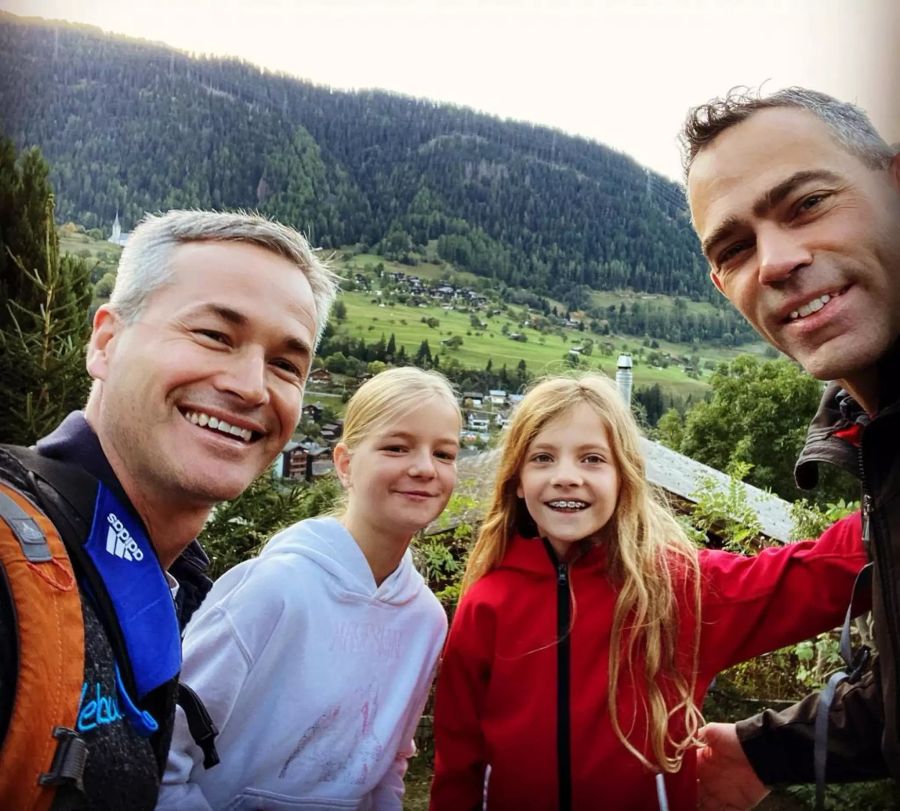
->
[87,241,316,518]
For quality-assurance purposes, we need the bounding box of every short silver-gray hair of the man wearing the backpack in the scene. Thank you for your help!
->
[109,211,338,345]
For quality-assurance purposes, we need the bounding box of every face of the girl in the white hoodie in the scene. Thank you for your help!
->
[334,394,460,543]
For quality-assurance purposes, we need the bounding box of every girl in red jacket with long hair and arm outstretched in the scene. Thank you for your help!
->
[431,375,865,811]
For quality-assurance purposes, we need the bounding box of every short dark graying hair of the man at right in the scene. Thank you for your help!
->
[678,87,894,182]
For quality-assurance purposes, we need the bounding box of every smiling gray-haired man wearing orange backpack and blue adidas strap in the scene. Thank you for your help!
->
[0,211,336,811]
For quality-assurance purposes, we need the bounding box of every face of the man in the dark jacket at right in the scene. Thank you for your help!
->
[688,108,900,410]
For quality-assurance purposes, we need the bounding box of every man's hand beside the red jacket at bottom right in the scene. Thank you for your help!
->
[697,724,769,811]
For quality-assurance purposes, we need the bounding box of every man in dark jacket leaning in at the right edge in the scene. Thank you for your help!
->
[681,88,900,809]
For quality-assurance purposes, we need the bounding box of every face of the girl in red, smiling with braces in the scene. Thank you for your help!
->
[516,402,619,559]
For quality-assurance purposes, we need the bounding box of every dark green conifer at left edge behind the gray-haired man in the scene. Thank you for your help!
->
[0,143,91,445]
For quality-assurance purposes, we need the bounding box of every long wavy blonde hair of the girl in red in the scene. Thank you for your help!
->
[462,374,703,772]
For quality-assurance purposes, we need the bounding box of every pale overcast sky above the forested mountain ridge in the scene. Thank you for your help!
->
[0,0,900,179]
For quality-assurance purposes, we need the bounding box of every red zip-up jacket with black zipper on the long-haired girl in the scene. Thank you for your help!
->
[430,513,866,811]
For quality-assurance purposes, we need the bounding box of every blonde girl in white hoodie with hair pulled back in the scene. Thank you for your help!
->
[159,368,461,811]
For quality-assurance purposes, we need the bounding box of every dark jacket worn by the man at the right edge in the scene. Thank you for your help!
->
[738,347,900,785]
